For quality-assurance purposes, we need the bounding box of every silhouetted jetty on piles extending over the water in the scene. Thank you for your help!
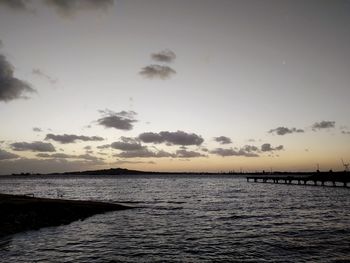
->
[246,172,350,187]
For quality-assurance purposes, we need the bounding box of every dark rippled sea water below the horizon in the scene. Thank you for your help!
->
[0,175,350,263]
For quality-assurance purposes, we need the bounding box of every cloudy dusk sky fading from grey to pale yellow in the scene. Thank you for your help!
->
[0,0,350,174]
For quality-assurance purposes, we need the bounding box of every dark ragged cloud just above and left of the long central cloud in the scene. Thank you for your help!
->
[97,110,137,130]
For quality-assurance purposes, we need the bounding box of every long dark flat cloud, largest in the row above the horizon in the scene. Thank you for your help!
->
[139,131,204,145]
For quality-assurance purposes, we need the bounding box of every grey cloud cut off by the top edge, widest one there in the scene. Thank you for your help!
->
[45,0,114,17]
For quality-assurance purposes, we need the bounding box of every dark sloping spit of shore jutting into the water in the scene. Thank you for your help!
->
[0,194,131,237]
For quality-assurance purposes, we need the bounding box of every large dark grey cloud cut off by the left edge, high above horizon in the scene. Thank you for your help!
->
[0,54,36,102]
